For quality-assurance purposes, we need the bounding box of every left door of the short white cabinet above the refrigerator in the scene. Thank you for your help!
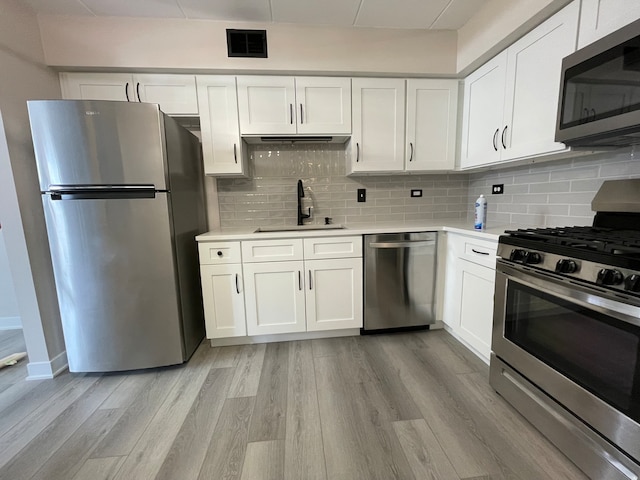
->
[60,73,136,102]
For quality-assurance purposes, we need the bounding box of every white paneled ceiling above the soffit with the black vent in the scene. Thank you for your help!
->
[22,0,488,30]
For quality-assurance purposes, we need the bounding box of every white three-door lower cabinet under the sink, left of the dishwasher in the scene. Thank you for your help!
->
[199,236,362,339]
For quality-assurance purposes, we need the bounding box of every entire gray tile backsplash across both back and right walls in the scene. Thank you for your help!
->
[212,144,640,229]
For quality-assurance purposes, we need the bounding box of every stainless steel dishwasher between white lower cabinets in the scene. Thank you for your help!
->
[362,232,437,333]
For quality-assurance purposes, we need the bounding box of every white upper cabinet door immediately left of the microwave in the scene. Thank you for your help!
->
[500,2,580,160]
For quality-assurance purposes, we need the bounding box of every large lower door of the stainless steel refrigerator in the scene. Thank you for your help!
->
[43,193,184,372]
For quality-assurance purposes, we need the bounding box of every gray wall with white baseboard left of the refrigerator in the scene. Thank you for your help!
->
[0,0,66,377]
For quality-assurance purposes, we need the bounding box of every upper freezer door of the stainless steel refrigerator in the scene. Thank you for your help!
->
[27,100,168,191]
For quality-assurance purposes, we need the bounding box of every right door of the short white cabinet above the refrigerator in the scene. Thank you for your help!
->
[133,74,198,115]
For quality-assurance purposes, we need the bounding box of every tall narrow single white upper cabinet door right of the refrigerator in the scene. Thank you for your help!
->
[197,75,246,176]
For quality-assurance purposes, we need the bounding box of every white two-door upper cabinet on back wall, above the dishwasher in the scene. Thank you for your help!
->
[349,78,458,174]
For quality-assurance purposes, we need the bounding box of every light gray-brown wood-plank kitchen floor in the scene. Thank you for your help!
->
[0,331,586,480]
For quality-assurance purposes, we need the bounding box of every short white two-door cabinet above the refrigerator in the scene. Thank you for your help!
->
[60,73,198,115]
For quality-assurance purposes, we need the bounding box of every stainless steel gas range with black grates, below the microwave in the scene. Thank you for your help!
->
[490,179,640,480]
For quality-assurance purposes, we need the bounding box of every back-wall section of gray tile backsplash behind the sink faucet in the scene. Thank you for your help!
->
[217,144,469,228]
